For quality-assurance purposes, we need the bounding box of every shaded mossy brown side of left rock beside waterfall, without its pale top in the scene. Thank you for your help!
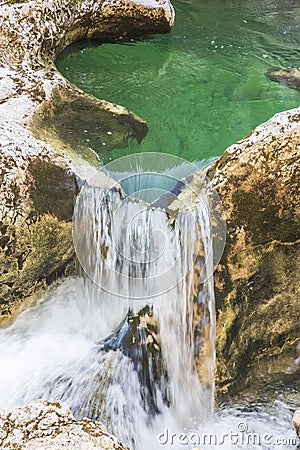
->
[0,158,78,317]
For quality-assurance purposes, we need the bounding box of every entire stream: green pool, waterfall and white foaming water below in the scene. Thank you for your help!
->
[0,0,300,450]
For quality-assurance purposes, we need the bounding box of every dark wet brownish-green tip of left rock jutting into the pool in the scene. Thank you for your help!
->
[32,88,148,165]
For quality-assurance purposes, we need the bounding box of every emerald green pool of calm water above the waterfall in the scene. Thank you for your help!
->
[57,0,300,162]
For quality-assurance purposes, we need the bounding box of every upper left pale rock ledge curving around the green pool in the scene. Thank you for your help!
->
[0,0,174,160]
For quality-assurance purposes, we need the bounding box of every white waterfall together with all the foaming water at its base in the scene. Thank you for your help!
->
[0,160,294,450]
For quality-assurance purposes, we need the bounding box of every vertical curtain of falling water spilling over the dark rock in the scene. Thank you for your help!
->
[70,161,215,442]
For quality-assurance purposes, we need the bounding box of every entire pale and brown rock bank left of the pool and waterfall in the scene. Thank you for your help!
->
[0,0,174,321]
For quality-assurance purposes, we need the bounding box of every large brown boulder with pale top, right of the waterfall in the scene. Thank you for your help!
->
[210,108,300,400]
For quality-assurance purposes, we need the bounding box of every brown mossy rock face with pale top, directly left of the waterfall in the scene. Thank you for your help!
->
[0,135,79,320]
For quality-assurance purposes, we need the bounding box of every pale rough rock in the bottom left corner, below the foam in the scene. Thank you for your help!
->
[0,400,128,450]
